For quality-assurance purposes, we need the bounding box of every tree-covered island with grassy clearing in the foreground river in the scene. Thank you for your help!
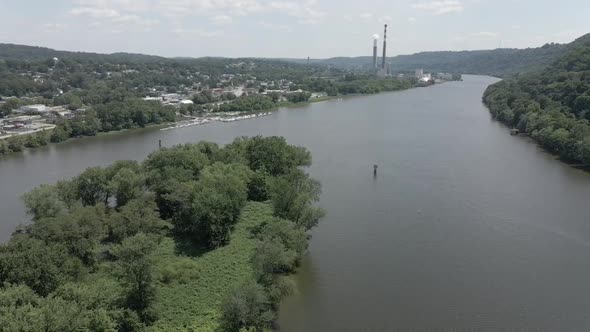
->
[0,136,324,332]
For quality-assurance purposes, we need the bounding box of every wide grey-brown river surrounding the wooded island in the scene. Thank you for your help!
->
[0,76,590,332]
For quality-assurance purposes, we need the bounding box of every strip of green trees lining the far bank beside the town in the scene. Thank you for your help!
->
[0,76,415,157]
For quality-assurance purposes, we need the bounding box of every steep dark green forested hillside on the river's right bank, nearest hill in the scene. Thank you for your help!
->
[484,34,590,164]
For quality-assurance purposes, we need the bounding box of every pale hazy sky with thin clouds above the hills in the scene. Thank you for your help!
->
[0,0,590,58]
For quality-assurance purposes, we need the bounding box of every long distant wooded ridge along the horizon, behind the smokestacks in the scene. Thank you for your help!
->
[0,34,590,77]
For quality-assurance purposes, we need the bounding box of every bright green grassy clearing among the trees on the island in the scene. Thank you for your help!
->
[150,202,272,332]
